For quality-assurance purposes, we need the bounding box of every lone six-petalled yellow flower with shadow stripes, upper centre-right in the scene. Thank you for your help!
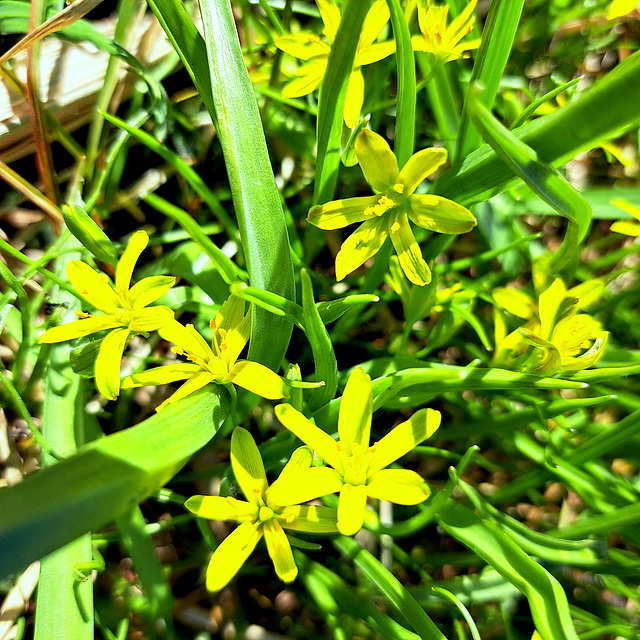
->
[307,129,476,285]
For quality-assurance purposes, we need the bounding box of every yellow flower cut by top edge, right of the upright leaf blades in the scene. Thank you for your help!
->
[411,0,480,64]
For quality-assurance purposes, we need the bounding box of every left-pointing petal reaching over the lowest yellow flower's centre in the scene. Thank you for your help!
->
[266,467,343,506]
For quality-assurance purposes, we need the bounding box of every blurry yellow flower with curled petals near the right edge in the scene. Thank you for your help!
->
[493,278,609,376]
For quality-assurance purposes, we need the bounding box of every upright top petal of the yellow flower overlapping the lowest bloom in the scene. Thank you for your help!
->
[338,366,373,448]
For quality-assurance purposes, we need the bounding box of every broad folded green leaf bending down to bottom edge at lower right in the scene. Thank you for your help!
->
[436,502,578,640]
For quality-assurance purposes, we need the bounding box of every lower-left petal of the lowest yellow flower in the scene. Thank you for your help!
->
[206,522,262,591]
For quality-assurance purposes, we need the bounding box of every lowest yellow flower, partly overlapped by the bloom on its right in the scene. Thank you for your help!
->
[184,427,337,591]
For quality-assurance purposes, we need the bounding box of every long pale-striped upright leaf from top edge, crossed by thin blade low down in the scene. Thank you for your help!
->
[200,0,295,369]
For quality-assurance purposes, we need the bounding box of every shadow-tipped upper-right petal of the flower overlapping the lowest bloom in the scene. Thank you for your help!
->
[367,409,441,477]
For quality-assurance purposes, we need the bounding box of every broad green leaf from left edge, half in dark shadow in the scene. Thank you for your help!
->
[0,387,229,576]
